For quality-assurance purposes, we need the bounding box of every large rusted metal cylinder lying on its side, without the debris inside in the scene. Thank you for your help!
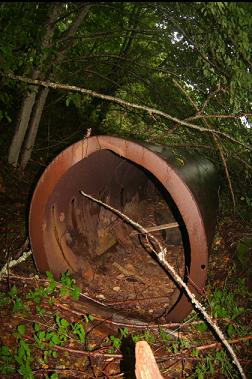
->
[29,136,218,321]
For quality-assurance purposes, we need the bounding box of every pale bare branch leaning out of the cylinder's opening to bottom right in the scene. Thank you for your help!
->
[80,191,246,379]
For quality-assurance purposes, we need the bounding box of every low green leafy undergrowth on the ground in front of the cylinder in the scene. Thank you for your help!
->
[0,272,252,379]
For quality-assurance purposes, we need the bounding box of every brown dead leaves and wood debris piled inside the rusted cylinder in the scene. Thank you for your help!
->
[77,191,186,322]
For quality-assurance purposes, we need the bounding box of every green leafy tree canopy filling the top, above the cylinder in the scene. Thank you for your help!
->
[0,2,252,217]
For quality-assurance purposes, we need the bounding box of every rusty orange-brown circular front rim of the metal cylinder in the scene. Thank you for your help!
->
[29,136,208,322]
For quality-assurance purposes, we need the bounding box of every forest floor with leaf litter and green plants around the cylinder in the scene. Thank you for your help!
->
[0,161,252,379]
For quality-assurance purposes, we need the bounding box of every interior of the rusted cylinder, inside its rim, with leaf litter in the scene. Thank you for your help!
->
[49,150,190,321]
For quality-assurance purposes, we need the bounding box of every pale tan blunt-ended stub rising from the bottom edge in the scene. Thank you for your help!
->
[135,341,164,379]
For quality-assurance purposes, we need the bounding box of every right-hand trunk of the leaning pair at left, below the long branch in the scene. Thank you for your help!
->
[20,88,49,170]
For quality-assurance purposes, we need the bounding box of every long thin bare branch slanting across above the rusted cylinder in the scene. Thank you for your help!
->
[2,73,252,151]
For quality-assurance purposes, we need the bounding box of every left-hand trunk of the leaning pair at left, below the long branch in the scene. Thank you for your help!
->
[8,92,36,167]
